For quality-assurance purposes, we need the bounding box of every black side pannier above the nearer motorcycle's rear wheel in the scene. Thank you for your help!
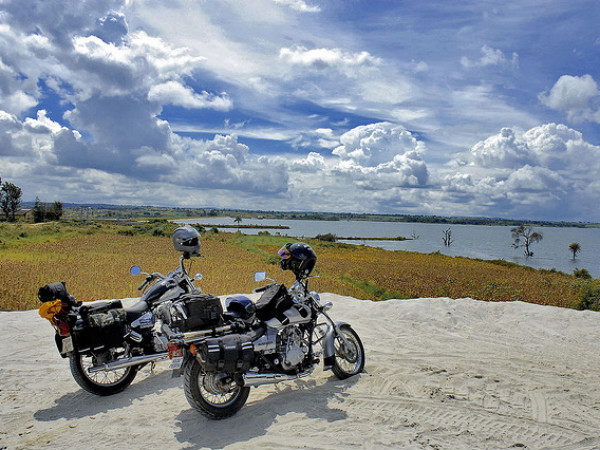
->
[198,334,254,373]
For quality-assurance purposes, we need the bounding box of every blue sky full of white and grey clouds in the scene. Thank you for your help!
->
[0,0,600,222]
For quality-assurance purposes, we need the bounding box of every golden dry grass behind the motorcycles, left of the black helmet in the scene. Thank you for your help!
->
[0,234,264,310]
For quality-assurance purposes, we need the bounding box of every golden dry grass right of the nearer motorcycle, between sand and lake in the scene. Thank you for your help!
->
[318,243,579,307]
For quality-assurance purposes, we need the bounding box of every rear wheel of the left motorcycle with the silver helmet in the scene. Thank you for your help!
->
[69,352,138,396]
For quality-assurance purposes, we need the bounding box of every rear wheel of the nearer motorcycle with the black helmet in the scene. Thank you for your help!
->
[183,358,250,419]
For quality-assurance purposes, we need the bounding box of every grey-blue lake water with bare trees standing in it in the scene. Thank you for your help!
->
[177,217,600,278]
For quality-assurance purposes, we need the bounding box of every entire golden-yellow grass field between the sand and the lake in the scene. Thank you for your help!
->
[0,224,580,310]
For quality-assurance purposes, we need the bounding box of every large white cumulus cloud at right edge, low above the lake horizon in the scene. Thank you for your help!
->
[440,123,600,219]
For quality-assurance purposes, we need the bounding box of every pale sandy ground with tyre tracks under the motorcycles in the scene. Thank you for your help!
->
[0,294,600,450]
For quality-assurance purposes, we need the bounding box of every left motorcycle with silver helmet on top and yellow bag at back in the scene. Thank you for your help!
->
[38,227,223,395]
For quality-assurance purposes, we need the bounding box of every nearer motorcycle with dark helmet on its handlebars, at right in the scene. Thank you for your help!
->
[169,243,365,419]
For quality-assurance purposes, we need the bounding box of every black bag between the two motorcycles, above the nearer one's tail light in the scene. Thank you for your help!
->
[173,294,223,332]
